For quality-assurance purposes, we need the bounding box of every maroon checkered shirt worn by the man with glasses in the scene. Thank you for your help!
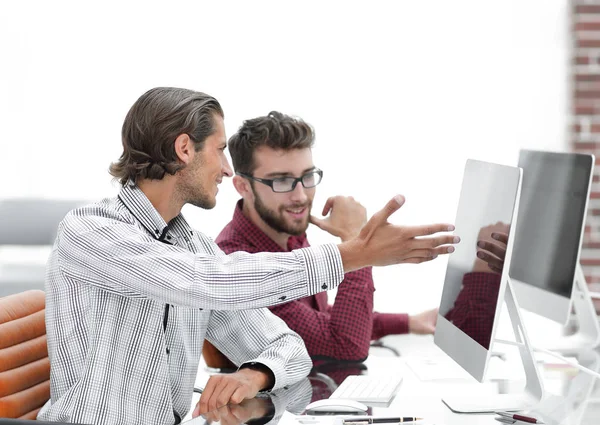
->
[216,200,408,361]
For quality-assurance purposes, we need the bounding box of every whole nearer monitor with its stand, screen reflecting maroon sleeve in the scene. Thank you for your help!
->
[434,160,543,412]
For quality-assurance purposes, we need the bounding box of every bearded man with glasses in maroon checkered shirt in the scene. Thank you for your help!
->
[210,112,437,361]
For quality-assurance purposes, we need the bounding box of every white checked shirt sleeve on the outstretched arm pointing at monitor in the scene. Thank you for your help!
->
[55,213,344,310]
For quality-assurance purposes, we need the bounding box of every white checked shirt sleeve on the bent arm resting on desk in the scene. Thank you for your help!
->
[206,308,312,389]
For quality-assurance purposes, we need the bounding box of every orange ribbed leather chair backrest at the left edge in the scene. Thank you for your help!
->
[0,290,50,419]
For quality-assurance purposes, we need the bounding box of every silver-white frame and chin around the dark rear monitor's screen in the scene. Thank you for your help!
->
[511,149,595,325]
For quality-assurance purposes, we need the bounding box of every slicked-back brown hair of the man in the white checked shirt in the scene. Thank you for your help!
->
[109,87,224,185]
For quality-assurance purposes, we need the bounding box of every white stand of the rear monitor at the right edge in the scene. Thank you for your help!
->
[544,264,600,354]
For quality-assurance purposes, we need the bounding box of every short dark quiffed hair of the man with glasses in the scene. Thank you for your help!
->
[228,111,315,175]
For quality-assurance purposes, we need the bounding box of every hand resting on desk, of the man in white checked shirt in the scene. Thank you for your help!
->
[192,368,273,418]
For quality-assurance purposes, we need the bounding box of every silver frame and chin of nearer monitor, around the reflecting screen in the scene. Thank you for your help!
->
[434,159,523,382]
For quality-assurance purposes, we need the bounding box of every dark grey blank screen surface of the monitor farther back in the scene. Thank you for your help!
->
[510,151,592,298]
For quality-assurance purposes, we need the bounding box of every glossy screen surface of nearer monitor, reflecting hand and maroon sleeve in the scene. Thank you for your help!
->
[440,161,519,349]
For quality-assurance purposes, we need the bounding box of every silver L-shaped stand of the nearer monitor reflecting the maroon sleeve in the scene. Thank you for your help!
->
[442,278,544,413]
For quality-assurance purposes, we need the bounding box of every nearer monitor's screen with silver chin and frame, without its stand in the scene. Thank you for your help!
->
[435,160,521,380]
